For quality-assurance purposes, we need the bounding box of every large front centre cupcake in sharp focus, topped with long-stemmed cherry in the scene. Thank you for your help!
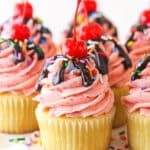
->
[35,1,115,150]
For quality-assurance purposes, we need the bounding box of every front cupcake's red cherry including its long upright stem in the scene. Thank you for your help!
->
[62,0,87,58]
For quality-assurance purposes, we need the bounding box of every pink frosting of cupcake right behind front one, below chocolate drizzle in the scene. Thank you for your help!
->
[104,41,130,87]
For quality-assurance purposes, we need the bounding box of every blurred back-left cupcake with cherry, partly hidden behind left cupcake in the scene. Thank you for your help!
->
[1,2,57,58]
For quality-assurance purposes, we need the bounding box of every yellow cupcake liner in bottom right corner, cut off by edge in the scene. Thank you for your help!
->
[127,111,150,150]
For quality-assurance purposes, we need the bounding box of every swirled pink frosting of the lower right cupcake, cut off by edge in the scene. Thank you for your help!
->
[122,63,150,116]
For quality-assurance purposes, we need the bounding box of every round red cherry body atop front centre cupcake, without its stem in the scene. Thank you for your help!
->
[62,38,87,58]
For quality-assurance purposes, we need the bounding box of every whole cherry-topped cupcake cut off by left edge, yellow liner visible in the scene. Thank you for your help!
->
[0,24,45,133]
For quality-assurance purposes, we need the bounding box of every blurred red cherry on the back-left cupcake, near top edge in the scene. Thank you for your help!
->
[14,2,33,18]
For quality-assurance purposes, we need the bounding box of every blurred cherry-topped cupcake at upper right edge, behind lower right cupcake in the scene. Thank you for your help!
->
[125,10,150,69]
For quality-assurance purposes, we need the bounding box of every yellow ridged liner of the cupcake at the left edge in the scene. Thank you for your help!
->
[0,93,38,133]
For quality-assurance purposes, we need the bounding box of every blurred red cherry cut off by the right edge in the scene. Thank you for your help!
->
[139,9,150,25]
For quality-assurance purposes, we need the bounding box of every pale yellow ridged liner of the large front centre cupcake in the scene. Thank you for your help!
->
[36,108,115,150]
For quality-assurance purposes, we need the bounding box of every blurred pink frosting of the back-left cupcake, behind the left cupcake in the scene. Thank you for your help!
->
[1,17,57,58]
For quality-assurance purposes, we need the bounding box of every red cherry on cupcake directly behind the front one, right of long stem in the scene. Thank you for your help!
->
[78,23,103,40]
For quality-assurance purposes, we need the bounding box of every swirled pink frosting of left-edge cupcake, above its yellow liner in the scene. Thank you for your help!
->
[0,40,44,95]
